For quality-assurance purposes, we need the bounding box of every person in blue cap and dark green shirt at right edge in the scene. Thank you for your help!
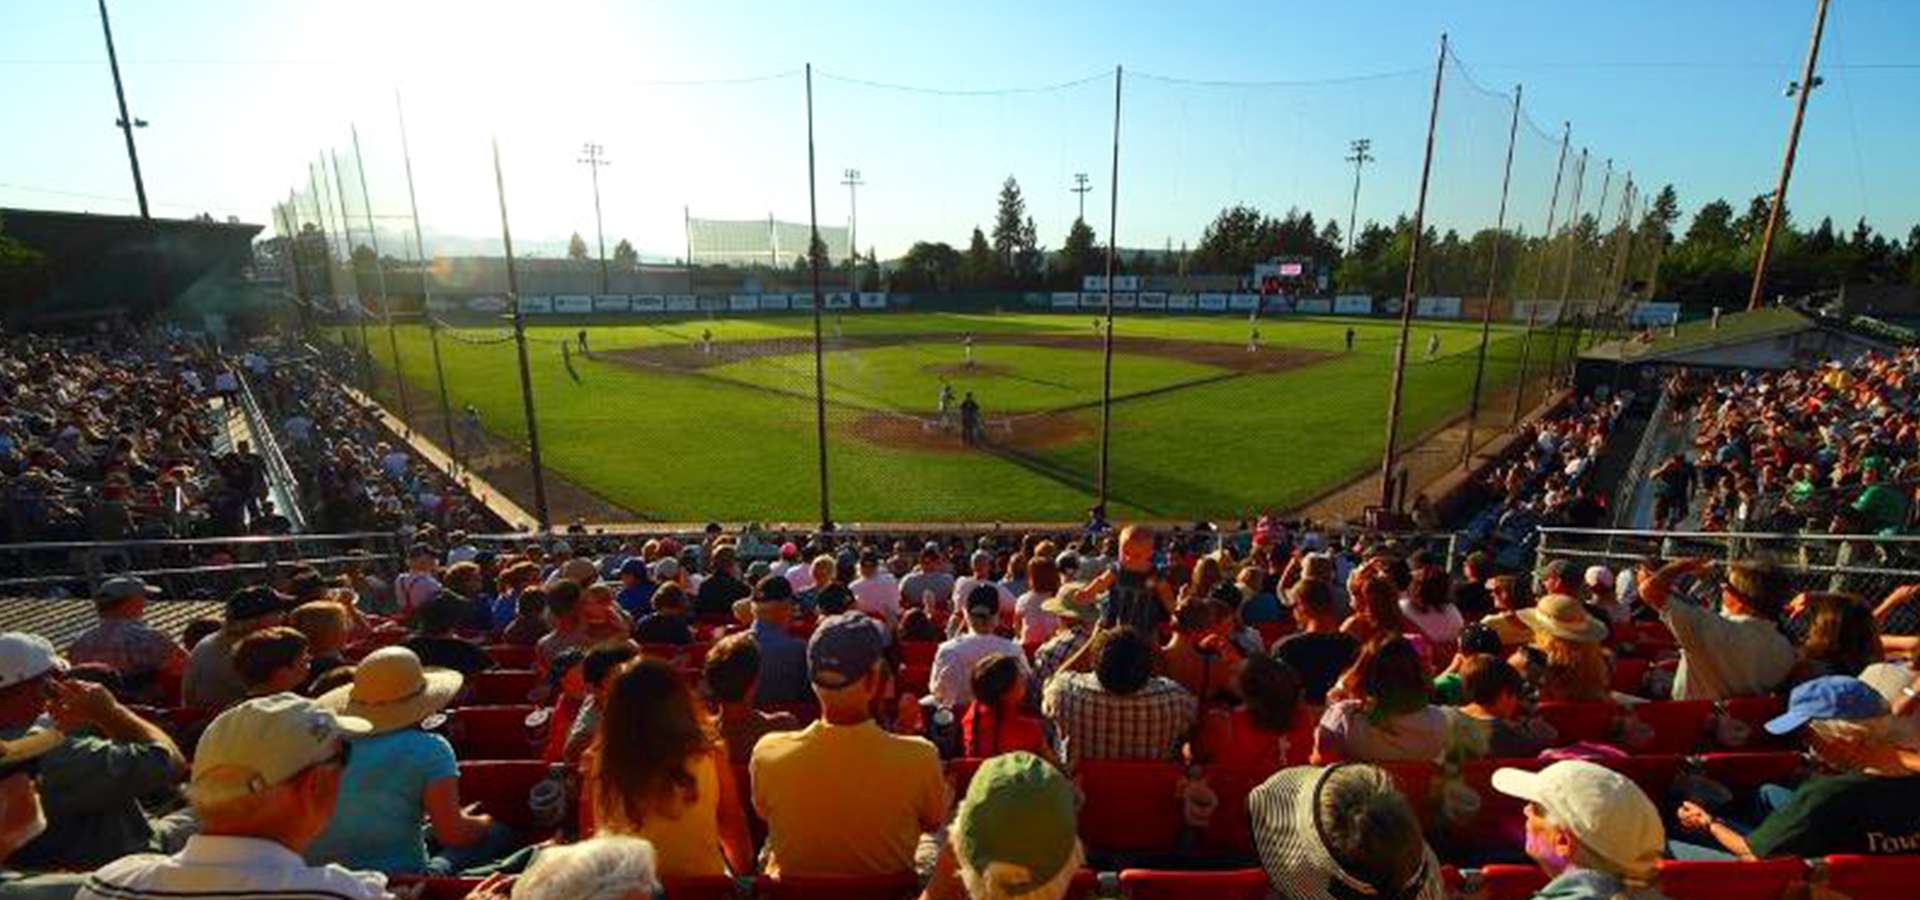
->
[1670,675,1920,860]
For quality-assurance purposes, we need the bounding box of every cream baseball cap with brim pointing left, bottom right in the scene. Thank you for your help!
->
[1494,760,1667,879]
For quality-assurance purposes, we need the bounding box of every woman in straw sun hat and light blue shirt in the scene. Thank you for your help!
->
[305,647,503,875]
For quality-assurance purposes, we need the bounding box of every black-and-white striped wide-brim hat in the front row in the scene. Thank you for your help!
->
[1246,766,1446,900]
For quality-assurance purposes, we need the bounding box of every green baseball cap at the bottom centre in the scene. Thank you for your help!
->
[954,750,1077,882]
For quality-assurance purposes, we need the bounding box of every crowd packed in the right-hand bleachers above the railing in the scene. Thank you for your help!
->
[1649,349,1920,535]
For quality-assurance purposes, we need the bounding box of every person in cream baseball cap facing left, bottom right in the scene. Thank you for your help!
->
[1494,760,1667,900]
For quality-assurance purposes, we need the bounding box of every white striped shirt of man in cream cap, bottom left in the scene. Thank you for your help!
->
[75,835,392,900]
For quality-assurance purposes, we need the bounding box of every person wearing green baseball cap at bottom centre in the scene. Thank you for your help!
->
[920,752,1085,900]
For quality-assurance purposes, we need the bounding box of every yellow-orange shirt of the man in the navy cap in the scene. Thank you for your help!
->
[748,720,947,877]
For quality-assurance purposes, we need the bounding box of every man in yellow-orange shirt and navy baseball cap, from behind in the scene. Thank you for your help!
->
[751,612,947,877]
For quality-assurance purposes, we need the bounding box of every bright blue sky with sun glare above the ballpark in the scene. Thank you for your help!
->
[0,0,1920,257]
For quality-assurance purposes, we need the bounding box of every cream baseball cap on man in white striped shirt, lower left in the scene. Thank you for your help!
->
[186,693,372,804]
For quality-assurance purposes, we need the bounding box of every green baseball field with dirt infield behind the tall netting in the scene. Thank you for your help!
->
[336,311,1546,524]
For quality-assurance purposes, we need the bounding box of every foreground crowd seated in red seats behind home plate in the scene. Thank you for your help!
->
[0,506,1920,900]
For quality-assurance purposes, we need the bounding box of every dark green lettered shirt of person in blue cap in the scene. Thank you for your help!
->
[1747,775,1920,858]
